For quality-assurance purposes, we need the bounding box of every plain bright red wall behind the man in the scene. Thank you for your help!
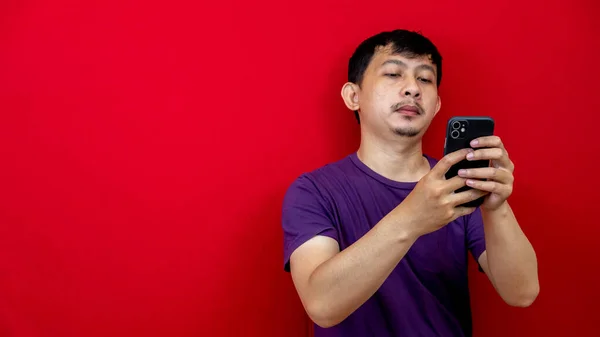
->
[0,0,600,337]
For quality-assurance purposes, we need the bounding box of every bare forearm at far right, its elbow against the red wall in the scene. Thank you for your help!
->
[482,202,539,306]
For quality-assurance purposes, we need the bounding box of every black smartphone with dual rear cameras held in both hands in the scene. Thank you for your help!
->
[444,116,494,207]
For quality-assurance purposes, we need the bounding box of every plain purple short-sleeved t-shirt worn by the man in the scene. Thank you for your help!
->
[282,153,485,337]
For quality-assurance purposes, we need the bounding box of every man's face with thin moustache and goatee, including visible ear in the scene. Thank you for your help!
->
[342,48,440,137]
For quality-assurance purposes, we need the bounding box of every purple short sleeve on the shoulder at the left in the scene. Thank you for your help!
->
[281,175,339,272]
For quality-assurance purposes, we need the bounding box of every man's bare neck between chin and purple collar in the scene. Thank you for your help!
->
[357,129,430,182]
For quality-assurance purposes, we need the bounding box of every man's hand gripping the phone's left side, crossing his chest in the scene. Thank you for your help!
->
[392,149,488,237]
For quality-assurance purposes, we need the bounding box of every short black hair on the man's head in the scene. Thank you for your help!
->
[348,29,442,124]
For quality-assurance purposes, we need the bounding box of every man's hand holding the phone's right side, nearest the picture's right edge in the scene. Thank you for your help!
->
[458,136,515,211]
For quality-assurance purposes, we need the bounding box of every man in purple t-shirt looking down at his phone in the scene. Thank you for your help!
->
[282,30,539,337]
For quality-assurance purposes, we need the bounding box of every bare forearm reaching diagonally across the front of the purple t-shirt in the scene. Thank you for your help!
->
[307,210,416,326]
